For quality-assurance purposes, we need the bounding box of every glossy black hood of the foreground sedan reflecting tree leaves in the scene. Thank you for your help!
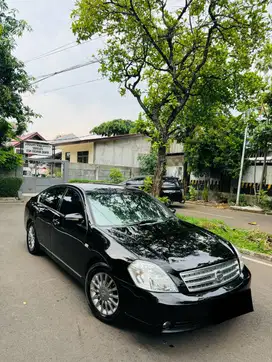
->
[103,218,235,271]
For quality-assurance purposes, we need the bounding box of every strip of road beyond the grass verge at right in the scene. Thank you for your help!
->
[175,203,272,234]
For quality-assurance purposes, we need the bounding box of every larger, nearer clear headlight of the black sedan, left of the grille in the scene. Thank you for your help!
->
[128,260,178,293]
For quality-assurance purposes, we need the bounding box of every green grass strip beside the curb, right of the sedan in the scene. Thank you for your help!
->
[177,214,272,255]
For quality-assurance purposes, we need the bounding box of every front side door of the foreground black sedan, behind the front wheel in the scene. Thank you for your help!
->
[51,187,91,277]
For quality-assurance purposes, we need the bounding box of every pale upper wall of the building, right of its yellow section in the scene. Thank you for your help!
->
[94,136,150,168]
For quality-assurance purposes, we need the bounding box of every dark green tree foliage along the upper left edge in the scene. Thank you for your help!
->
[0,0,37,150]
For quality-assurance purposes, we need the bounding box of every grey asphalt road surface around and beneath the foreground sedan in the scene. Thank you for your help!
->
[0,205,272,362]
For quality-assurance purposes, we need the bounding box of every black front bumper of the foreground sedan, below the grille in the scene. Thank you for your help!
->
[119,267,253,333]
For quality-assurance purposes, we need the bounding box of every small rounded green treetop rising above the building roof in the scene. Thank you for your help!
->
[91,119,134,137]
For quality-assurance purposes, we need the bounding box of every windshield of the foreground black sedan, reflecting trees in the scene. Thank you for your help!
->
[87,189,174,226]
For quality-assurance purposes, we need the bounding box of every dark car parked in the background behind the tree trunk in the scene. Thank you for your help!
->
[122,176,185,203]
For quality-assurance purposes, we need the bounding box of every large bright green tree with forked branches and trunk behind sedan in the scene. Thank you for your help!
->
[72,0,271,195]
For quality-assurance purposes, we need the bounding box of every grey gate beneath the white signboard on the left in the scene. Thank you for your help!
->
[21,158,69,194]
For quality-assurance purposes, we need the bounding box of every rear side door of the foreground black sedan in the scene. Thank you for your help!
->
[35,186,66,251]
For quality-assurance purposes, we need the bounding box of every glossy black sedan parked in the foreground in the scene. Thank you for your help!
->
[25,184,253,333]
